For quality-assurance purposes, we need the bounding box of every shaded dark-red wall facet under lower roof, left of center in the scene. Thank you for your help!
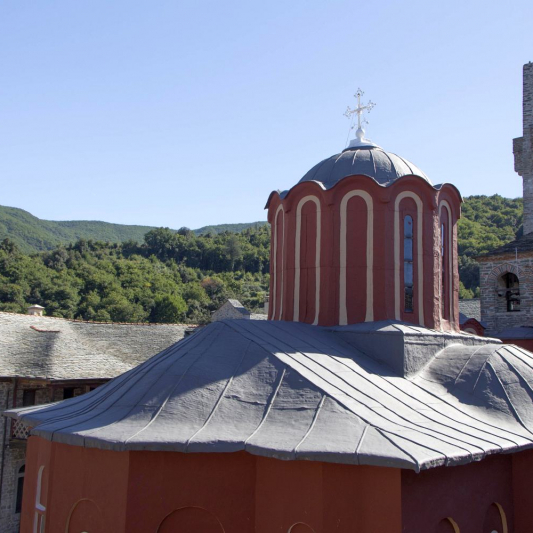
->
[125,452,255,533]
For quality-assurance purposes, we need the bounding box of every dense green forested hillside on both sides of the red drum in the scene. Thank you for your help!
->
[0,195,522,323]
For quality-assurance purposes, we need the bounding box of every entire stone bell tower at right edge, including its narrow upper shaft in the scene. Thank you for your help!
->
[477,62,533,349]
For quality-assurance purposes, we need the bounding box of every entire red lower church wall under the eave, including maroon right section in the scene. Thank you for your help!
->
[21,437,533,533]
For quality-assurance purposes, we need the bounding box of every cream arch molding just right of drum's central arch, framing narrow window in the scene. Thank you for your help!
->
[394,191,424,326]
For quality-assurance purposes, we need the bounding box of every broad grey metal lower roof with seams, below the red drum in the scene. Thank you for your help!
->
[8,320,533,471]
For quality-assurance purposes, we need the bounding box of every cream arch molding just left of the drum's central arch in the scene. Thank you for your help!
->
[293,194,322,326]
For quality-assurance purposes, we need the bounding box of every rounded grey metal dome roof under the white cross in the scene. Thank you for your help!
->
[299,145,432,189]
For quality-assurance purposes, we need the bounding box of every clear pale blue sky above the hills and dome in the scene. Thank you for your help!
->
[0,0,533,228]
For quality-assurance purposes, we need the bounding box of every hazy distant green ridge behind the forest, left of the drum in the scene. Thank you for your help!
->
[0,206,266,253]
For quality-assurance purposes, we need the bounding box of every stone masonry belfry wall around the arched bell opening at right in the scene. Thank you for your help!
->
[479,253,533,336]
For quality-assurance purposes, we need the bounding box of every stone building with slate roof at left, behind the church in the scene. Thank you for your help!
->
[0,308,190,533]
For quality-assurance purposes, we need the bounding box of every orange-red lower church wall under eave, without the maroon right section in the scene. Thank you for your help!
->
[21,437,401,533]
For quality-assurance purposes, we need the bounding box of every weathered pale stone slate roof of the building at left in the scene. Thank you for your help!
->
[0,312,188,380]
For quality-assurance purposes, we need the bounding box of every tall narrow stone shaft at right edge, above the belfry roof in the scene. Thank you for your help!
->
[513,61,533,235]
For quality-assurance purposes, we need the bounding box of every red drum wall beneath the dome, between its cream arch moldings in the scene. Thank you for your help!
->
[268,176,461,331]
